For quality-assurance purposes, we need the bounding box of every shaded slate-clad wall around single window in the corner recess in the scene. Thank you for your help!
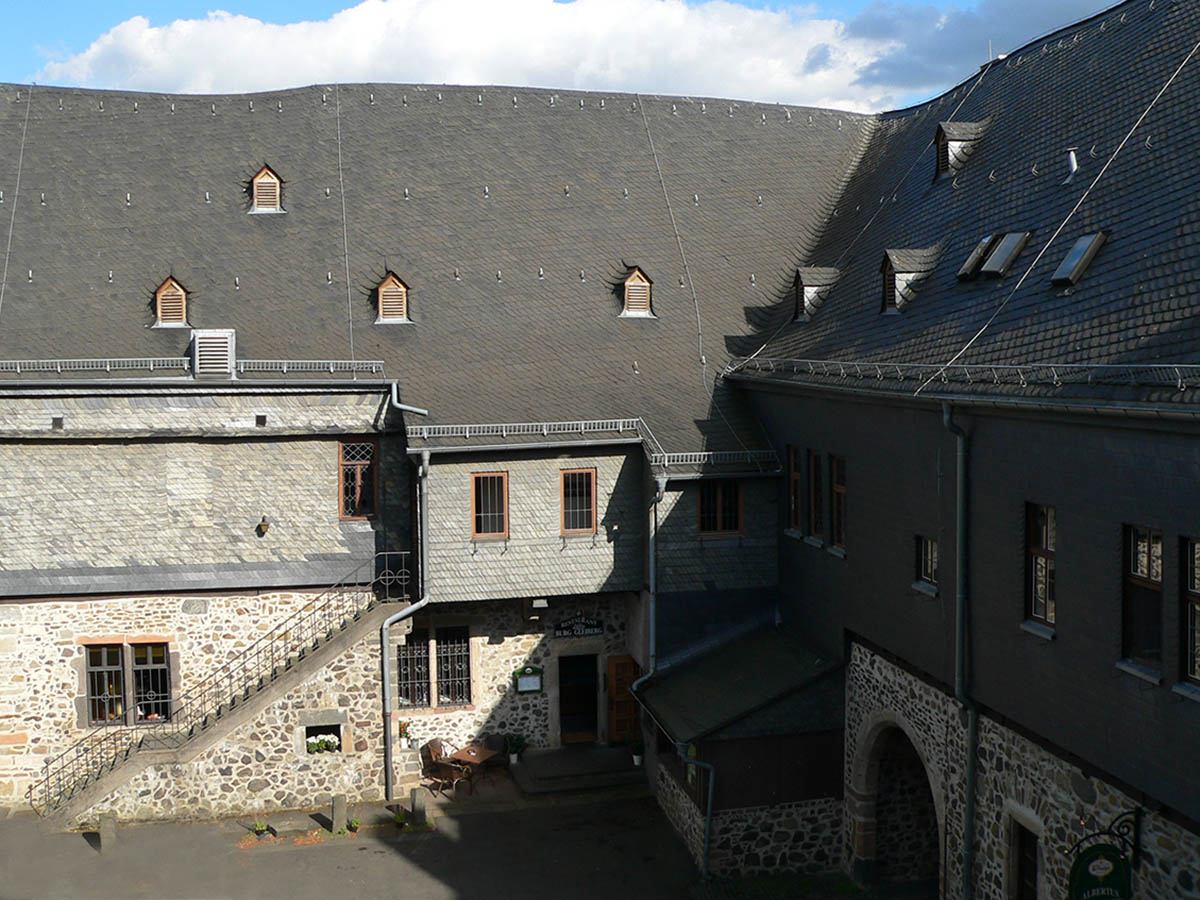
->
[656,479,779,594]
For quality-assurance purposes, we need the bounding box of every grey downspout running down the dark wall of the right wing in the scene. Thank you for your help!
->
[942,402,979,900]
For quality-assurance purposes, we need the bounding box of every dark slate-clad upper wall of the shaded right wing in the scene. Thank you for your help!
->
[755,394,1200,821]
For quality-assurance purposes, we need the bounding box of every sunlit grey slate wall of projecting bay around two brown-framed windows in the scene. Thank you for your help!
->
[427,449,646,601]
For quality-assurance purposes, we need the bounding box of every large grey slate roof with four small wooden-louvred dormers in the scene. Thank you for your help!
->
[0,85,875,452]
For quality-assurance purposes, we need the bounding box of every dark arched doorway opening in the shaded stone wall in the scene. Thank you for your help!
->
[847,715,943,898]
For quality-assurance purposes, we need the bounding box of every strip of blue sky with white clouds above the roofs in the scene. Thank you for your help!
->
[0,0,1110,109]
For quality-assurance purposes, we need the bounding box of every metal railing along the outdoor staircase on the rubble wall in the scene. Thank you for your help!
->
[25,551,409,816]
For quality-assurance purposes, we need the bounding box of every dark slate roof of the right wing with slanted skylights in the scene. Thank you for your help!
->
[734,0,1200,401]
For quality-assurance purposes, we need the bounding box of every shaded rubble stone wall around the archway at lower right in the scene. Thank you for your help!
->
[845,644,1200,900]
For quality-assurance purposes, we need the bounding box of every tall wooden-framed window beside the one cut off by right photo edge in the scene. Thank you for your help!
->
[1121,526,1163,668]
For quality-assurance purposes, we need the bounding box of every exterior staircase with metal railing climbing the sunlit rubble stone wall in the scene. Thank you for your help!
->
[26,552,410,824]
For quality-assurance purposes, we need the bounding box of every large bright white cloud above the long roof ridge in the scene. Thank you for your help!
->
[38,0,894,109]
